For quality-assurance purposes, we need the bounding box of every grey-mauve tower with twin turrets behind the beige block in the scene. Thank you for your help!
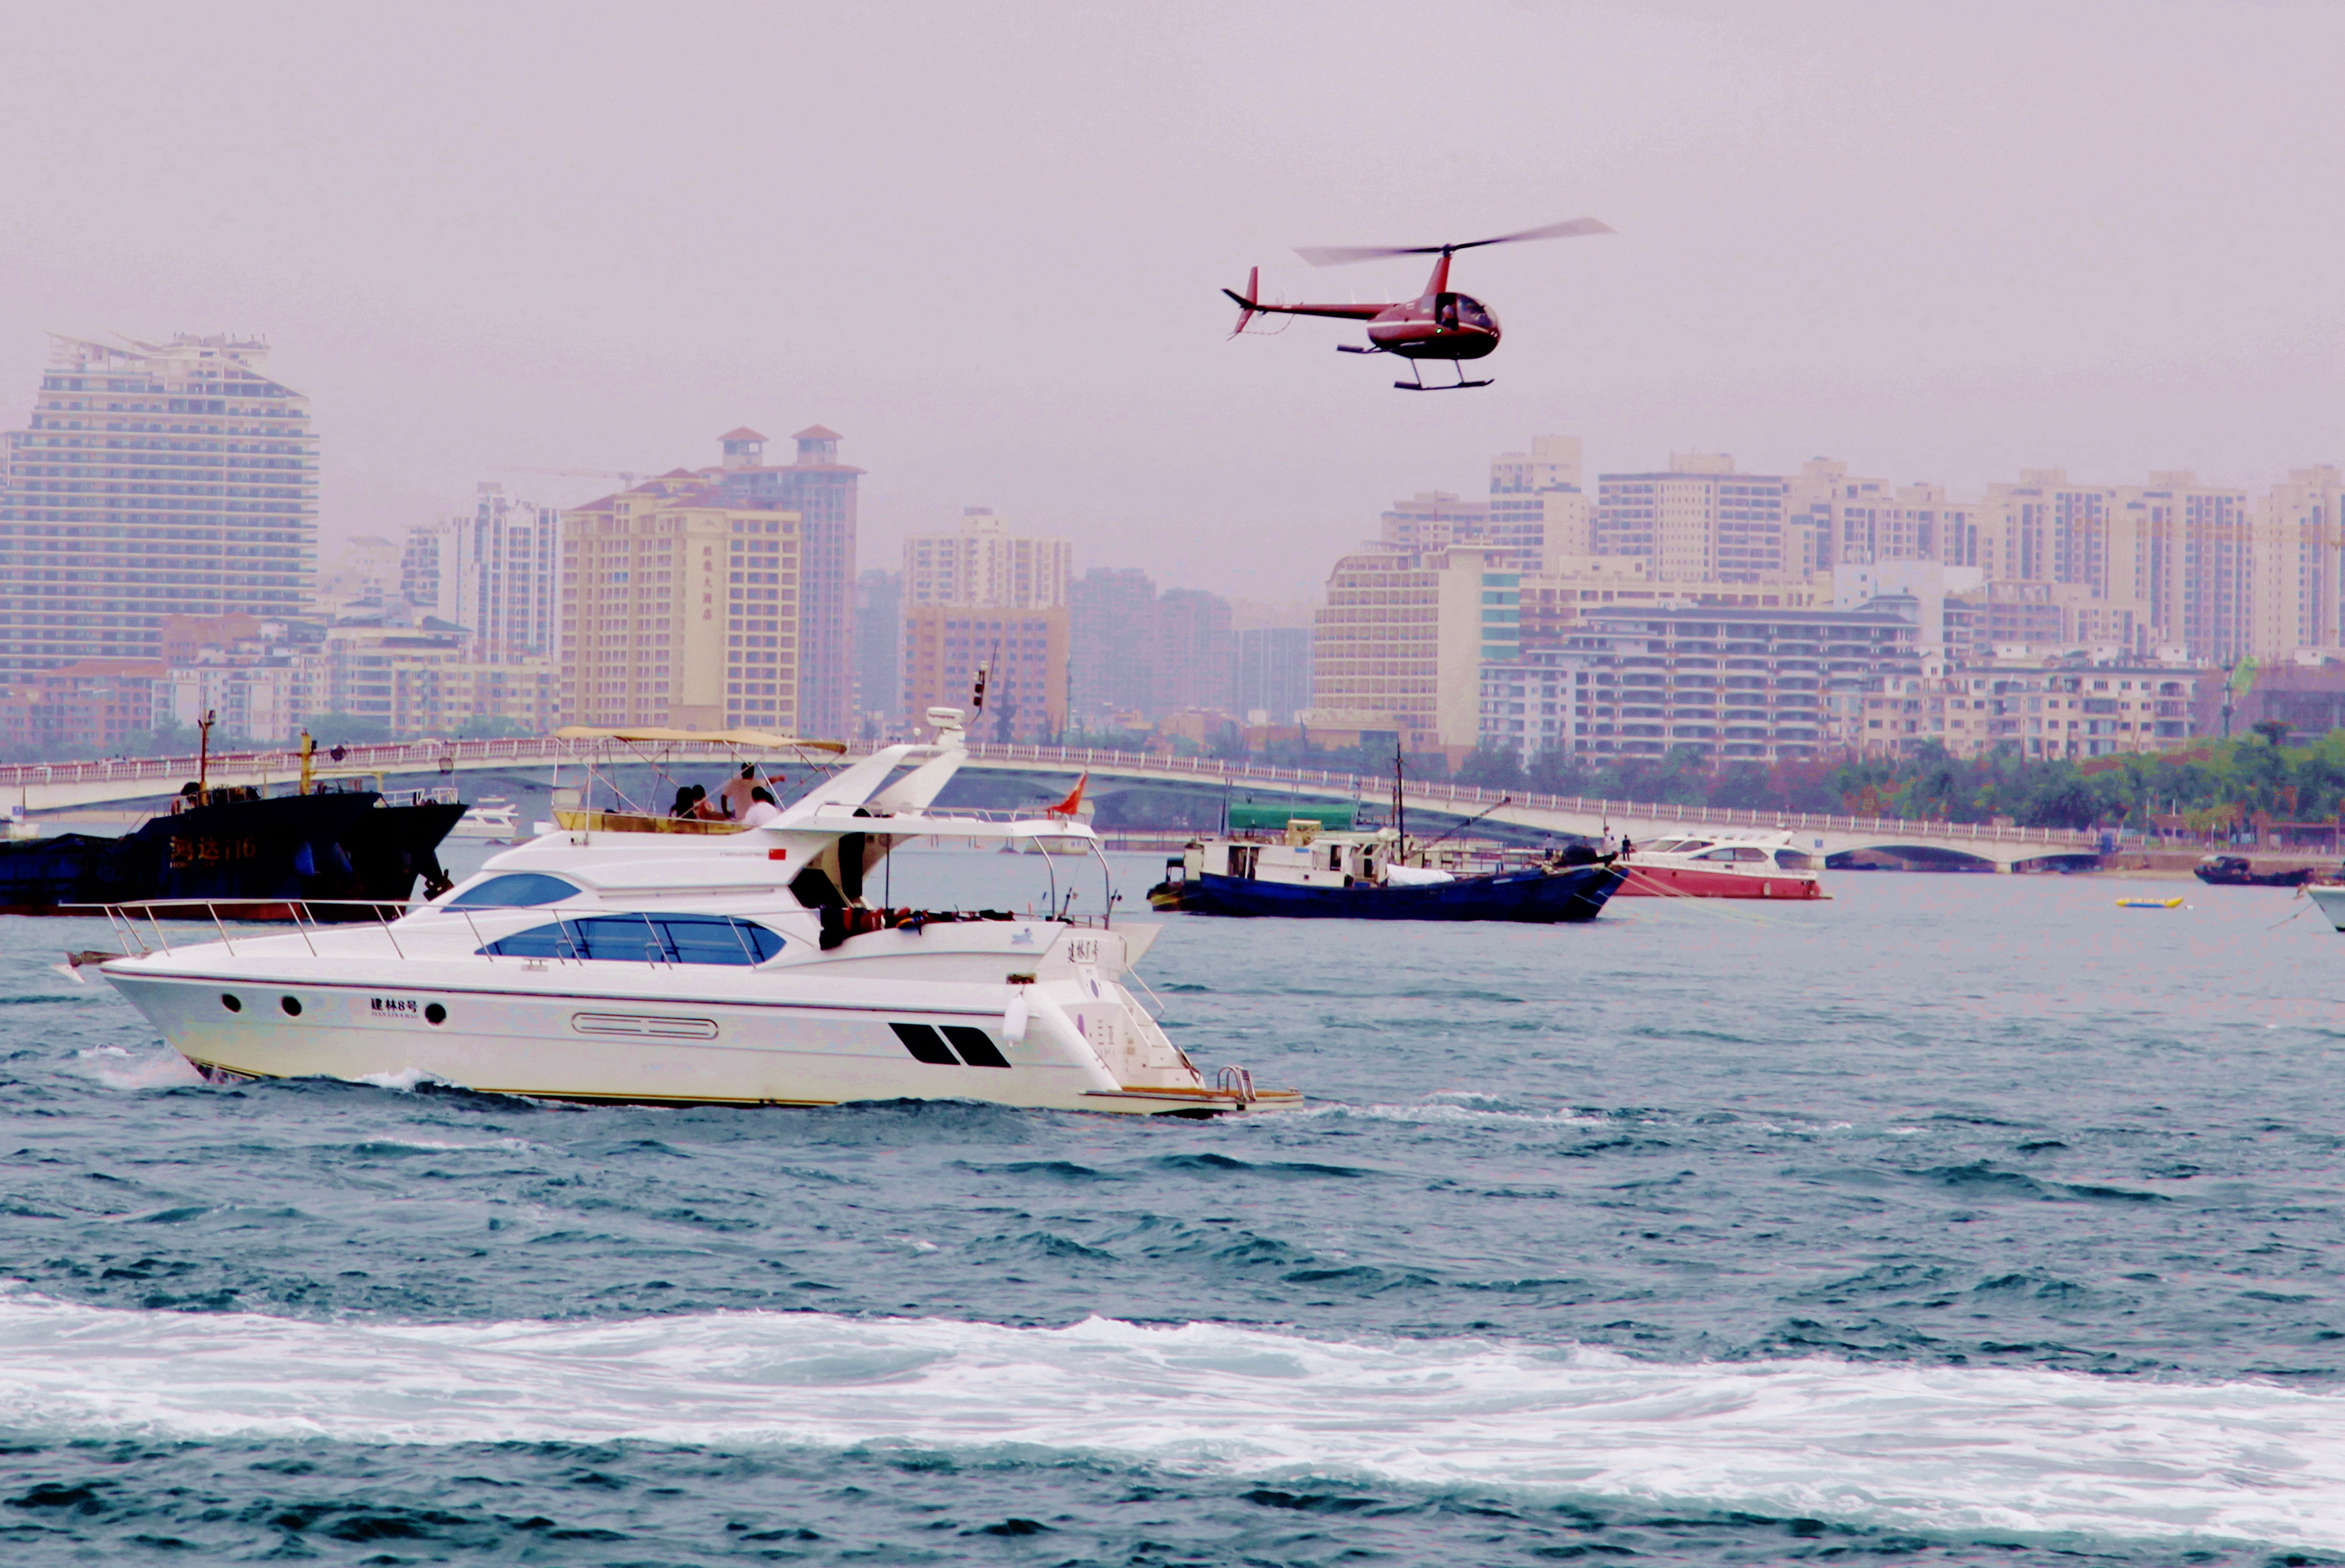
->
[701,424,863,739]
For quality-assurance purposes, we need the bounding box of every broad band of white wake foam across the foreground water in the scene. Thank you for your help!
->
[0,1296,2345,1549]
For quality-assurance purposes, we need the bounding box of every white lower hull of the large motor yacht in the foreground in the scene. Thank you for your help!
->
[103,944,1248,1116]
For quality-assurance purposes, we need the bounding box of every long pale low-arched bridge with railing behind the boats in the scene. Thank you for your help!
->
[0,736,2099,872]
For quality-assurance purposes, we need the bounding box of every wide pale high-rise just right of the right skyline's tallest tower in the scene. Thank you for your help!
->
[1592,452,1810,584]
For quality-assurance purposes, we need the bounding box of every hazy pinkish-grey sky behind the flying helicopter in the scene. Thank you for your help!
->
[0,0,2345,598]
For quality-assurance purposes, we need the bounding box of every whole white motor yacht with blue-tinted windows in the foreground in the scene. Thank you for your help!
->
[87,708,1299,1116]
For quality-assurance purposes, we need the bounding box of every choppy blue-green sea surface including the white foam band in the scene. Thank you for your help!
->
[0,851,2345,1566]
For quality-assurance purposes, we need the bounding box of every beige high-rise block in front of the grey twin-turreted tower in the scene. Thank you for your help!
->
[560,474,800,734]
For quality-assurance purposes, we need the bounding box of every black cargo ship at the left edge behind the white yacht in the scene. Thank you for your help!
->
[0,785,464,921]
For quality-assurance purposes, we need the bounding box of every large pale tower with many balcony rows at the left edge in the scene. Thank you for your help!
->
[0,335,317,682]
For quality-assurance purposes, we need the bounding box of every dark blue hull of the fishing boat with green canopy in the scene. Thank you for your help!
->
[1149,865,1620,923]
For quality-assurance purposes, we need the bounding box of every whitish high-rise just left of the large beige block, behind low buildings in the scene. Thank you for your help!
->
[399,485,560,663]
